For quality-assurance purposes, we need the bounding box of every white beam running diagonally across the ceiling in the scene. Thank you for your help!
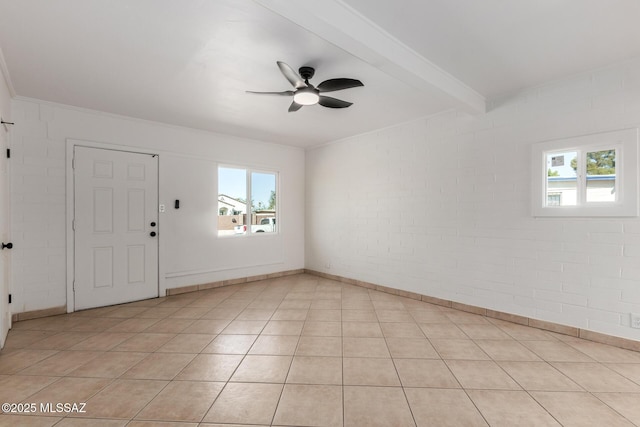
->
[254,0,487,114]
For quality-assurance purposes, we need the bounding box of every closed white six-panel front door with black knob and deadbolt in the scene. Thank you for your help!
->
[74,146,158,310]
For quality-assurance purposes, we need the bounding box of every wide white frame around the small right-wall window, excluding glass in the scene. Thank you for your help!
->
[531,128,638,217]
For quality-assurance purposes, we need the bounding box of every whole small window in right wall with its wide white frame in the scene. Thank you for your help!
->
[532,129,638,216]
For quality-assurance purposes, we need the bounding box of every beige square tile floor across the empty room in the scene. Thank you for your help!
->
[0,275,640,427]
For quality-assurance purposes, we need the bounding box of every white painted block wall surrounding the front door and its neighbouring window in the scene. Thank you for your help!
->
[11,98,304,313]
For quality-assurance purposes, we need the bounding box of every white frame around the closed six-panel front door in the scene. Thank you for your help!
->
[66,139,165,313]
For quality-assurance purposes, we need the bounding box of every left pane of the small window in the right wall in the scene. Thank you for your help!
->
[546,151,578,206]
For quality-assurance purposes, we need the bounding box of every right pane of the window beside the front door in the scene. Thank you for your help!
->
[251,172,276,233]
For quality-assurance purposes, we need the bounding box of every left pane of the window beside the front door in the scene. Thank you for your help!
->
[218,167,247,236]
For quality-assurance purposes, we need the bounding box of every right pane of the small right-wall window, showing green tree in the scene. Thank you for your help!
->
[586,150,616,203]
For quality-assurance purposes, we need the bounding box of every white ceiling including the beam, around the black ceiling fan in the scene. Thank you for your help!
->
[0,0,640,147]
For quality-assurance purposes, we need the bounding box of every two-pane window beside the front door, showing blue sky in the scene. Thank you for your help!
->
[218,166,278,236]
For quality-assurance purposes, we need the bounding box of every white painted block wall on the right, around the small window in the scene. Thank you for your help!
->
[305,60,640,340]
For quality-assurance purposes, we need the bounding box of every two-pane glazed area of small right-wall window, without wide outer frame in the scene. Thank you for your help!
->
[546,149,617,207]
